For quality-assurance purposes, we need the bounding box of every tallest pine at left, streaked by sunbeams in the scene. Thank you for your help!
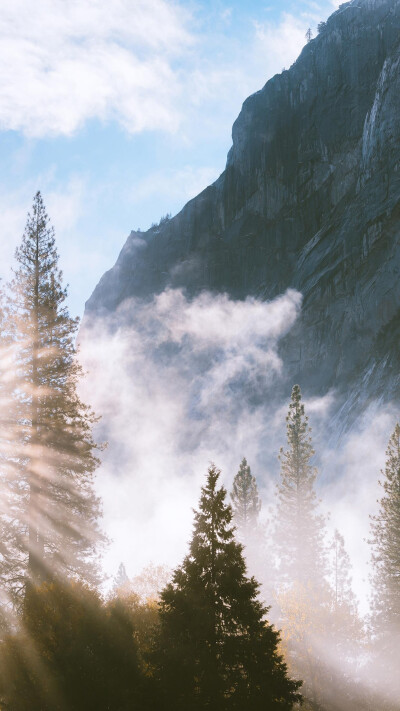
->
[3,192,102,589]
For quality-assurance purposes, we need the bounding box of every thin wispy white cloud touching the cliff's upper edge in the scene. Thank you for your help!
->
[181,4,329,141]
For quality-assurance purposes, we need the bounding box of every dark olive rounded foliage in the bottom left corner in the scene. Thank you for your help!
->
[0,582,151,711]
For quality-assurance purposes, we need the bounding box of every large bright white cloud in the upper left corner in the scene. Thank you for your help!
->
[0,0,191,136]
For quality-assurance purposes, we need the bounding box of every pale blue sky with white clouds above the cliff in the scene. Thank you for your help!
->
[0,0,339,315]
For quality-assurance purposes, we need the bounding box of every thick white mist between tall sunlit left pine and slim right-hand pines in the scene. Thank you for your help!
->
[81,290,301,573]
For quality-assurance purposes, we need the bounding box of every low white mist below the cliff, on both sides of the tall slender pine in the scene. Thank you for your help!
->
[80,290,395,610]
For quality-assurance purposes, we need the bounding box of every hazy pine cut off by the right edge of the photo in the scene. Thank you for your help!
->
[369,423,400,709]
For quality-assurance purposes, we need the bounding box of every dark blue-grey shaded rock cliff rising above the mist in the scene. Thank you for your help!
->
[86,0,400,419]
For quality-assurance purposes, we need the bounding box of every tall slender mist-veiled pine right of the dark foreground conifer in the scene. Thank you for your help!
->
[274,385,331,710]
